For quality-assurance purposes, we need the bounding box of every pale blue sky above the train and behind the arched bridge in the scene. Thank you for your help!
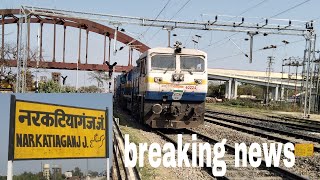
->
[0,0,320,86]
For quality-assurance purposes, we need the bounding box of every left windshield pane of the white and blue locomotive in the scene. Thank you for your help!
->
[151,55,176,70]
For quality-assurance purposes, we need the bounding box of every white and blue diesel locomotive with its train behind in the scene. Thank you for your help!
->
[114,42,208,129]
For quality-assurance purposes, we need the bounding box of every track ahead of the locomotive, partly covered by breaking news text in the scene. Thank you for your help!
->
[156,129,306,180]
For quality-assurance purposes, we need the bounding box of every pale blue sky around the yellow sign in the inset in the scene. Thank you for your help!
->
[0,93,113,176]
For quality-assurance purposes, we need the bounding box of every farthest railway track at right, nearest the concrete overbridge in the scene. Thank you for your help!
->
[207,110,320,133]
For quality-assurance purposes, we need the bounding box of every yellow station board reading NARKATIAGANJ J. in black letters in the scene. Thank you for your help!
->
[9,96,108,160]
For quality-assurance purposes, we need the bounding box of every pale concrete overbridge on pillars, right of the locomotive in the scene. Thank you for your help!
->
[208,69,302,100]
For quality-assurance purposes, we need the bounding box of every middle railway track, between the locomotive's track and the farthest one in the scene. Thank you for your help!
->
[205,114,320,152]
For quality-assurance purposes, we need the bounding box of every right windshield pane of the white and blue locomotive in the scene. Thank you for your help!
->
[180,56,204,72]
